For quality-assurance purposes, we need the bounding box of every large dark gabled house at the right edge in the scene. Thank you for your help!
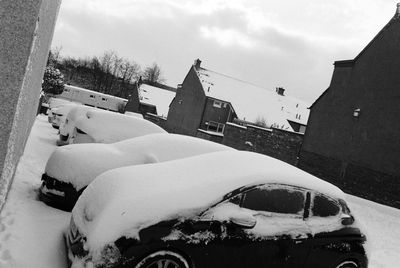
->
[298,4,400,208]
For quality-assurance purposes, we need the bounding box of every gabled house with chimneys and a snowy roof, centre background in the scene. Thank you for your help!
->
[167,59,309,136]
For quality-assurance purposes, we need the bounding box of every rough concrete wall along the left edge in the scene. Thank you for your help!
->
[0,0,61,209]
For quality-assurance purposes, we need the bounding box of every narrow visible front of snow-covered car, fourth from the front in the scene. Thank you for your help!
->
[57,105,96,146]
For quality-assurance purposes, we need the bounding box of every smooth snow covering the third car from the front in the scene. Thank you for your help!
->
[75,110,166,143]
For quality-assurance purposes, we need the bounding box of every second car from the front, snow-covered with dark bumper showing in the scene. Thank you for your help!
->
[39,133,233,210]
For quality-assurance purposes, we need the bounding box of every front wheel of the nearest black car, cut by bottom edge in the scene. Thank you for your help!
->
[135,250,190,268]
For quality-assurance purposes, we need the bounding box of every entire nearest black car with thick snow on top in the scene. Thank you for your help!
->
[65,151,368,268]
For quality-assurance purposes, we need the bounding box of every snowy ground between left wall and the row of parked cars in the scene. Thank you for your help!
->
[0,116,70,268]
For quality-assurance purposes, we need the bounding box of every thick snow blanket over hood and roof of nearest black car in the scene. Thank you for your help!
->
[72,151,344,253]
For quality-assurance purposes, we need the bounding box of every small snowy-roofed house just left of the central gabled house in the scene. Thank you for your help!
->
[138,84,175,118]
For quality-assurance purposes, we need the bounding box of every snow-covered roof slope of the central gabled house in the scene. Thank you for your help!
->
[194,67,309,130]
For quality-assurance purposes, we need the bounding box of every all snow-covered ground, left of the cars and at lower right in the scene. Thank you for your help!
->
[0,116,400,268]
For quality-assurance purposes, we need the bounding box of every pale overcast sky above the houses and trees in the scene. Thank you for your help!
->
[52,0,396,102]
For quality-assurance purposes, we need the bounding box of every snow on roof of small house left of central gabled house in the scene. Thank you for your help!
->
[139,84,175,117]
